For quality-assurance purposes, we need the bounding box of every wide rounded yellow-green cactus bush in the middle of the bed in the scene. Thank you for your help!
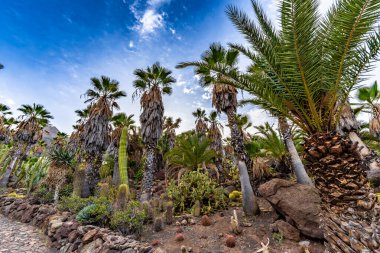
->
[167,170,227,213]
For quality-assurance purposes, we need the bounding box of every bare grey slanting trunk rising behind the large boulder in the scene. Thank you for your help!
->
[278,117,314,186]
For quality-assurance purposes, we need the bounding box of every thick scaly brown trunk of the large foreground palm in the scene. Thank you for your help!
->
[305,133,380,253]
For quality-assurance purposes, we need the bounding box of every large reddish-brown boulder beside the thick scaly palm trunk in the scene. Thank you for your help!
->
[259,179,323,239]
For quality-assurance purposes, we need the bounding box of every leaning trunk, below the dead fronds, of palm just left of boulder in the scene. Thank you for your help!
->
[227,108,259,215]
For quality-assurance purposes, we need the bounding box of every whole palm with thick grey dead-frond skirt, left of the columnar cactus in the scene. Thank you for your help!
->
[80,76,126,196]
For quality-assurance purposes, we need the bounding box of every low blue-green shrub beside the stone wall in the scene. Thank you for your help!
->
[75,198,111,225]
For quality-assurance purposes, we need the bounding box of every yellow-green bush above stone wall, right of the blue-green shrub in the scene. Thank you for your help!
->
[110,201,147,235]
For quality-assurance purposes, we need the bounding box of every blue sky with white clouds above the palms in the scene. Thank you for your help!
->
[0,0,378,132]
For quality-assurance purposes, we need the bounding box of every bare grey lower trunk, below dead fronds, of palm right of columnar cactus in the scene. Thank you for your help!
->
[140,145,156,202]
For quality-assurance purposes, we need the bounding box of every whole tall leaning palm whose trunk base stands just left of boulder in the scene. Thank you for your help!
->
[177,43,258,215]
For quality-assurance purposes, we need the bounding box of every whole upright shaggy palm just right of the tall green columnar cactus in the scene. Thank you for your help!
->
[133,62,176,201]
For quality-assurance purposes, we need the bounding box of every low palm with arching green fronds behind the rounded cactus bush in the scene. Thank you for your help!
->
[165,134,216,169]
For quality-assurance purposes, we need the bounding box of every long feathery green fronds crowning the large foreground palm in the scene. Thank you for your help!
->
[209,0,380,134]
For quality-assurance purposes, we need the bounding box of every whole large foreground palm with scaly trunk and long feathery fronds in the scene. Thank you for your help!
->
[214,0,380,252]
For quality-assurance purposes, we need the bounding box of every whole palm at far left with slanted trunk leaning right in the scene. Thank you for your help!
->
[0,103,53,187]
